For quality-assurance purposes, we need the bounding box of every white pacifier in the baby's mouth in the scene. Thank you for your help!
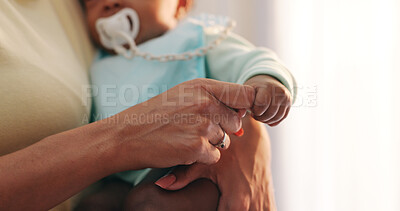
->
[96,8,140,50]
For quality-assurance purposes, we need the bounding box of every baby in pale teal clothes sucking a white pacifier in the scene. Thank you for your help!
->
[84,0,296,191]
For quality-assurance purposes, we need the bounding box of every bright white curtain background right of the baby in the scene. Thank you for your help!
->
[195,0,400,211]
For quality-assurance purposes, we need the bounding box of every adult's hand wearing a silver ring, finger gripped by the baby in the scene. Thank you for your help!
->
[111,79,254,170]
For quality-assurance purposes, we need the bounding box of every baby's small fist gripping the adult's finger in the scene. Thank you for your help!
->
[245,75,292,127]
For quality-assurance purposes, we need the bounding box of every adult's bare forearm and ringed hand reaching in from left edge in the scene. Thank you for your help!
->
[0,79,255,210]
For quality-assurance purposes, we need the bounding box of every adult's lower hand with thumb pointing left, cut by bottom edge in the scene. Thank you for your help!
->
[156,118,276,211]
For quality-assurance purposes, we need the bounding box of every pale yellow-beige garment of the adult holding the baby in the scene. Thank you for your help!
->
[0,0,94,210]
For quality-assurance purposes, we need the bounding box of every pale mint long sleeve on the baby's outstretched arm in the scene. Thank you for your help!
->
[205,32,297,101]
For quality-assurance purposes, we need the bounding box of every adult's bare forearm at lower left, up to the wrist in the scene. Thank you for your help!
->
[0,120,122,210]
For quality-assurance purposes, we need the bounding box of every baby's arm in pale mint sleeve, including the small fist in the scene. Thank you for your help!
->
[206,33,296,126]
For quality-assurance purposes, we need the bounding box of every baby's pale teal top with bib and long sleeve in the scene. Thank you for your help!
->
[91,16,296,184]
